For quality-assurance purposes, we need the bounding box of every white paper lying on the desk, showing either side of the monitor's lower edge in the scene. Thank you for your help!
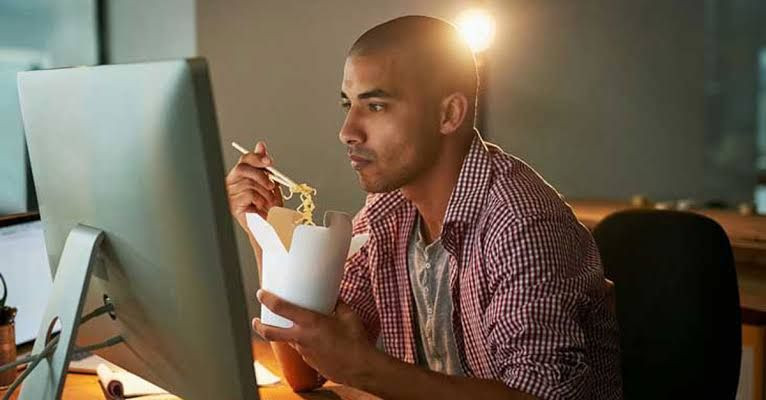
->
[91,359,280,400]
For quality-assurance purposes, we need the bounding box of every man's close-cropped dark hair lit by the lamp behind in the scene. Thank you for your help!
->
[348,15,479,124]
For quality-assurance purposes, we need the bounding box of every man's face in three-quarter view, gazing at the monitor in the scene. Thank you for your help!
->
[339,52,441,193]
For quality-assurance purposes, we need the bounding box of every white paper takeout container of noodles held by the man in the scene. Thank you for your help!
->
[245,207,369,328]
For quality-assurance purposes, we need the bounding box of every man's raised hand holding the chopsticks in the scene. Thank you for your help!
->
[226,142,283,235]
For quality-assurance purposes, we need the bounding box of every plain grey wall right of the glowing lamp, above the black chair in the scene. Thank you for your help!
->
[487,0,755,203]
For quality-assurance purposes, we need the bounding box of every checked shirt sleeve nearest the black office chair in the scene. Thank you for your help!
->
[485,214,603,399]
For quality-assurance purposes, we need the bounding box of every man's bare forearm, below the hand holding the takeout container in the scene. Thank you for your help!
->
[350,350,535,400]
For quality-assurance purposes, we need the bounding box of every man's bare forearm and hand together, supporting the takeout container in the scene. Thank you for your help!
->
[253,290,534,400]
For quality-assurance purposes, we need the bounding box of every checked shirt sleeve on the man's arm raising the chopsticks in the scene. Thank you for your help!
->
[338,209,380,341]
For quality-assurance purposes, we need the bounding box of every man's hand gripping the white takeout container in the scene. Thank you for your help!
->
[253,290,377,386]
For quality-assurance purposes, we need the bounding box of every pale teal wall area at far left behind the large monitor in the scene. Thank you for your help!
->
[0,0,98,216]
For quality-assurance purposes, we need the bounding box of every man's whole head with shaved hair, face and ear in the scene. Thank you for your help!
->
[338,16,478,193]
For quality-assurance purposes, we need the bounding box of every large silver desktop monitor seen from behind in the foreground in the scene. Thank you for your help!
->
[18,59,258,399]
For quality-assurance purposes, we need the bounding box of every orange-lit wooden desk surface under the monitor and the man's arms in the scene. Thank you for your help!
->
[0,339,377,400]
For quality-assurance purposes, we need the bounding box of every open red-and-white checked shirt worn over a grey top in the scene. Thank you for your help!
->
[340,134,622,399]
